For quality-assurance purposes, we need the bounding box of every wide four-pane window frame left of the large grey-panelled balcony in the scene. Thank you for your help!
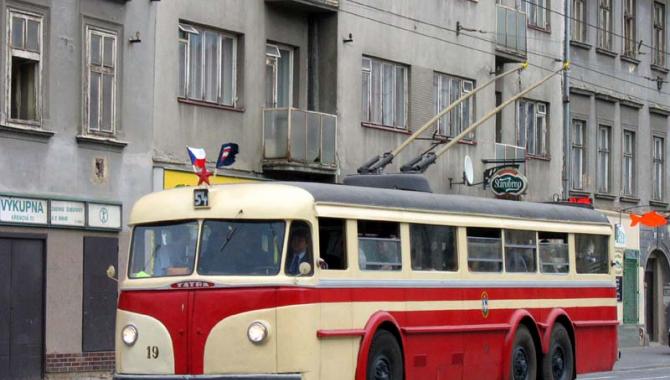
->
[177,20,239,108]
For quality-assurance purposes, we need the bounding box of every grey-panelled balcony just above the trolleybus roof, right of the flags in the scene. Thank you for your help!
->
[263,108,337,176]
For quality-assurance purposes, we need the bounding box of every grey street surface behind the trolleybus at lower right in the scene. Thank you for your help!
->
[577,345,670,380]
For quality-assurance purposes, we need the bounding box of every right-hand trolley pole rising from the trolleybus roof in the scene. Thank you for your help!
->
[402,62,570,173]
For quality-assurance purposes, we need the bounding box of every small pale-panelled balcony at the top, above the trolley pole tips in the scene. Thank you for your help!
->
[496,4,527,63]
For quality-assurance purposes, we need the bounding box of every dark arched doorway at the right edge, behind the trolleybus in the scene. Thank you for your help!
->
[644,250,670,344]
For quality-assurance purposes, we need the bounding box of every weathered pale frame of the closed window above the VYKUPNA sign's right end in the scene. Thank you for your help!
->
[83,24,119,136]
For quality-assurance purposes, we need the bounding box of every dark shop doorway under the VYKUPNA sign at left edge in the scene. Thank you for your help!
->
[0,238,44,380]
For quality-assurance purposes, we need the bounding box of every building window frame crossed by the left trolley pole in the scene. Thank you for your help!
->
[433,71,476,141]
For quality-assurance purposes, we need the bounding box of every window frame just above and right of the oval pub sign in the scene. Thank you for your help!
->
[516,98,550,159]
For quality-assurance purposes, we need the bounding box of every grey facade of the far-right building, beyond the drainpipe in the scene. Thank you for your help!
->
[566,0,670,344]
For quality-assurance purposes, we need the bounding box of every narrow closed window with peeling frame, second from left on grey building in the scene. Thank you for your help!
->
[85,26,116,134]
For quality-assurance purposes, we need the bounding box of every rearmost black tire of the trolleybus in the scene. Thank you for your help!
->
[542,323,575,380]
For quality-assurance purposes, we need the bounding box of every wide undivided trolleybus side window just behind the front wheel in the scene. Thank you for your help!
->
[409,224,458,271]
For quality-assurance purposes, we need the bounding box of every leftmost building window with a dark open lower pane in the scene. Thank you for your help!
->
[7,11,42,125]
